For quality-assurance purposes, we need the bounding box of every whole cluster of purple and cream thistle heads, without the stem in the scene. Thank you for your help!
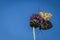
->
[30,12,52,30]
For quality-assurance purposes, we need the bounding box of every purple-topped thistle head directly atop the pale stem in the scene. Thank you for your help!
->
[30,14,42,28]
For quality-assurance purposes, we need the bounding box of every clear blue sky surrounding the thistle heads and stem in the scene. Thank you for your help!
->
[0,0,60,40]
